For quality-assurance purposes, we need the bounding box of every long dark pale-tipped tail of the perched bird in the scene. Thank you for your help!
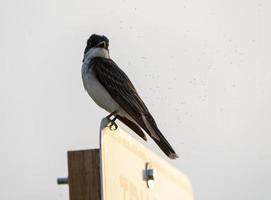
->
[143,114,178,159]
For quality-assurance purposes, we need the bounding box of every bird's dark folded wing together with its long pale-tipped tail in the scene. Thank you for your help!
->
[90,57,177,158]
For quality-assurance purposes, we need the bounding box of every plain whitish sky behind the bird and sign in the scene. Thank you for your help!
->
[0,0,271,200]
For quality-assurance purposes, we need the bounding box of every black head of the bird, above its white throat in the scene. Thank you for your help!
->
[84,34,109,54]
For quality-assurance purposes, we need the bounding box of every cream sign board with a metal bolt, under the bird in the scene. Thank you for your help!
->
[100,119,193,200]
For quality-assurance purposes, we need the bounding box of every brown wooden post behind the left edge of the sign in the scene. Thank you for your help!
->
[68,149,101,200]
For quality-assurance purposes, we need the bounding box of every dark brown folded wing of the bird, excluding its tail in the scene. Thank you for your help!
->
[90,57,152,131]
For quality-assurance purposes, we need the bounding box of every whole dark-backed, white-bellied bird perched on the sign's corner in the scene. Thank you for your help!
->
[81,34,178,159]
